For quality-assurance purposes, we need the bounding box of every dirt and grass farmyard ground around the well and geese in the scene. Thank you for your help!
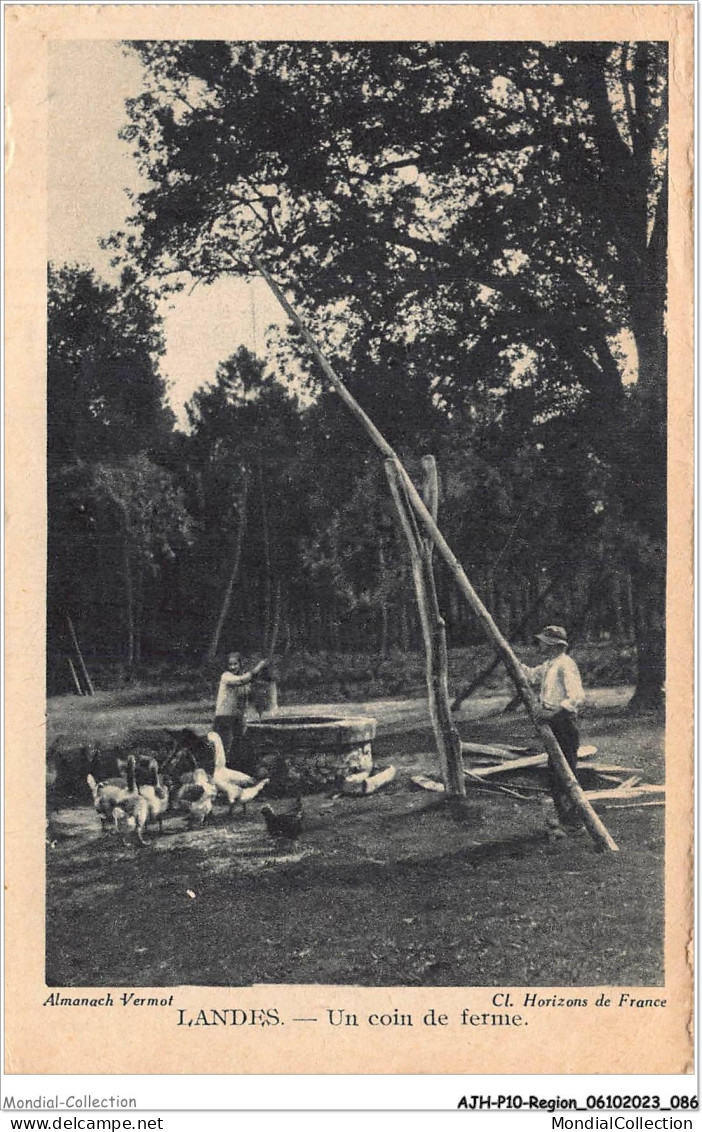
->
[46,688,664,986]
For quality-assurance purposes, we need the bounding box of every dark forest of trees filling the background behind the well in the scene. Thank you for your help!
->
[48,42,668,708]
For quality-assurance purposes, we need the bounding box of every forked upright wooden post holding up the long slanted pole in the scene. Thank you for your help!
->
[385,456,465,798]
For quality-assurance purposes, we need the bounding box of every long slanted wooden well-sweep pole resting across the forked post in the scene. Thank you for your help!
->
[251,257,618,852]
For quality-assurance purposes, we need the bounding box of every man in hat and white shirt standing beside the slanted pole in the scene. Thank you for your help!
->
[522,625,585,829]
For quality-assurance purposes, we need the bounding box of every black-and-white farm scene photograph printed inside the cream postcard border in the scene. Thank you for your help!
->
[45,40,668,987]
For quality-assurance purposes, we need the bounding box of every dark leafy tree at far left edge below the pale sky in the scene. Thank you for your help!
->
[46,266,180,666]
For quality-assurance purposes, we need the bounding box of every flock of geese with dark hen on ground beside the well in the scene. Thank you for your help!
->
[87,731,289,844]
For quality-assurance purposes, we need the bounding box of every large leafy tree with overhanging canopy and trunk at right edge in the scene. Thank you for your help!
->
[113,42,667,705]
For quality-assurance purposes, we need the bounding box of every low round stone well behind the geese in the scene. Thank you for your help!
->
[246,714,376,796]
